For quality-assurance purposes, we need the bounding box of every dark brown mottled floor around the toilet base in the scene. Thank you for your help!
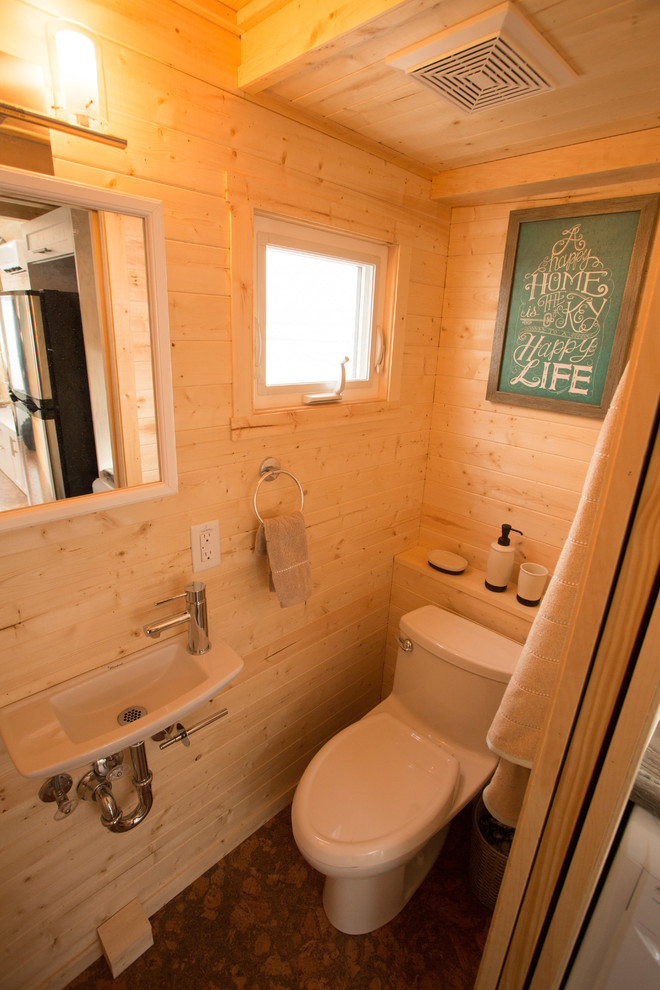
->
[69,808,491,990]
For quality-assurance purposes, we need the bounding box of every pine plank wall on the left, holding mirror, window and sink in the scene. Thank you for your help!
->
[0,0,449,990]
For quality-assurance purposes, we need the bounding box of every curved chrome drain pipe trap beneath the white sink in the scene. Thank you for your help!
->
[77,742,153,832]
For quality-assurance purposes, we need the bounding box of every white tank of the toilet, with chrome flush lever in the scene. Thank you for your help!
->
[392,605,522,752]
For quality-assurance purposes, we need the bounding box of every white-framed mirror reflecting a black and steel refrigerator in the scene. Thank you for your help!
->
[0,168,177,530]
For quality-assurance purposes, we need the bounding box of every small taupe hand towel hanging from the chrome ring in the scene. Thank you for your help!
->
[254,512,312,608]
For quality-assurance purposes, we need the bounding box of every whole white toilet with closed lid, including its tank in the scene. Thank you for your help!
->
[291,605,522,935]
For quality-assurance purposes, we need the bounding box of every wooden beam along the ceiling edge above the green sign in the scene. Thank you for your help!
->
[431,127,660,206]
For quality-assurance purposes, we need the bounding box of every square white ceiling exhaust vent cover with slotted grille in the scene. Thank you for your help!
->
[388,3,575,113]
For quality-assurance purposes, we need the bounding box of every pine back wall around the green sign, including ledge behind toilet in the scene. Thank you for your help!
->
[384,179,660,691]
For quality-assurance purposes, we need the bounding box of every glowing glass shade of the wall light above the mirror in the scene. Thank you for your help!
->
[46,20,108,130]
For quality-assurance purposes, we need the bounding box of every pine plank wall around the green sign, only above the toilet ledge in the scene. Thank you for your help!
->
[420,197,600,577]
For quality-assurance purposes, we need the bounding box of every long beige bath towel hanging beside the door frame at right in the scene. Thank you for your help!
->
[483,373,627,826]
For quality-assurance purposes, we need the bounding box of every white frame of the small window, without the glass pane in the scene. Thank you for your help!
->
[253,210,391,410]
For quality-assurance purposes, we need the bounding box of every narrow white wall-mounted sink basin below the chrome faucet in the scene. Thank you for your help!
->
[0,640,243,777]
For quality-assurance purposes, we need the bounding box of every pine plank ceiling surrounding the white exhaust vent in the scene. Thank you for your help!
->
[201,0,660,190]
